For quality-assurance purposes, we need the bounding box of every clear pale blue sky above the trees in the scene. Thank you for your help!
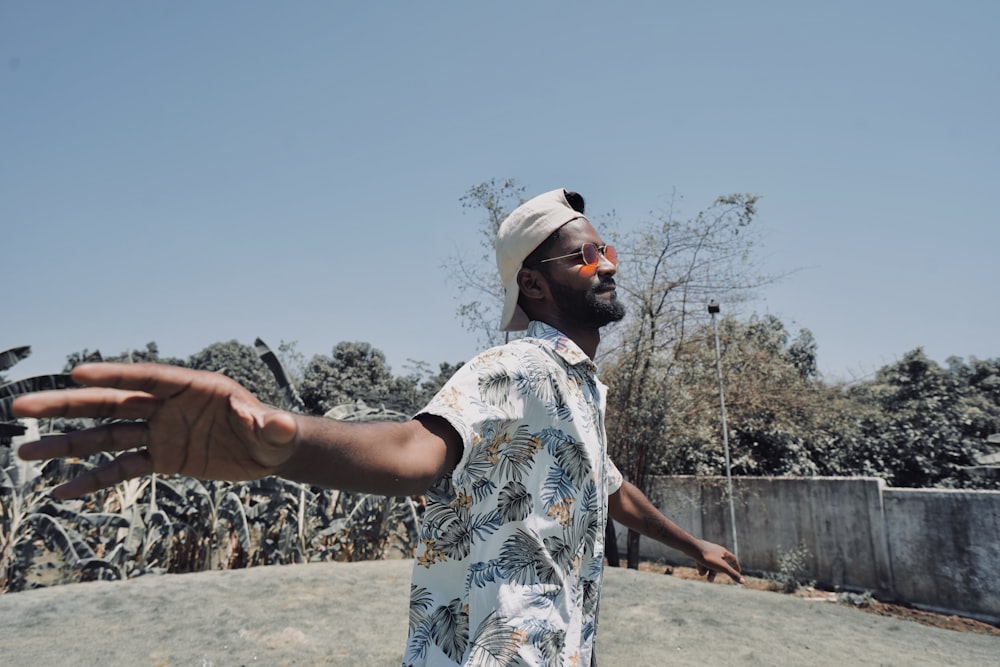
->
[0,0,1000,380]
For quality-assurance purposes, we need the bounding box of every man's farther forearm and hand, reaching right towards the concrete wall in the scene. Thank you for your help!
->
[608,482,743,584]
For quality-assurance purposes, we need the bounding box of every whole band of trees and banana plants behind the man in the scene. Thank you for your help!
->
[0,184,1000,591]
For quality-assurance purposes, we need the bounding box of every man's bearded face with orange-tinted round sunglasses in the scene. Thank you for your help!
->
[539,218,625,328]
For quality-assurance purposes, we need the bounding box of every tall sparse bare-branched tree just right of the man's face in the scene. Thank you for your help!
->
[602,194,772,567]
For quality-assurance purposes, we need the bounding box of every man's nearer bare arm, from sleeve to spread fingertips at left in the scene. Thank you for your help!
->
[12,364,462,497]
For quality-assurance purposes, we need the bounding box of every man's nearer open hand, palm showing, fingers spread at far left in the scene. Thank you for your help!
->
[12,363,296,498]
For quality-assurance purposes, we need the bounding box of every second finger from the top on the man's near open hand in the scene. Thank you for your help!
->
[11,387,161,419]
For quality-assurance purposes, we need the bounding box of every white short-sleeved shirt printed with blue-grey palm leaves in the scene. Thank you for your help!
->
[403,322,622,667]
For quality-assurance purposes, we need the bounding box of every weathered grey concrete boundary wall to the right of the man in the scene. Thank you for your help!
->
[618,476,1000,622]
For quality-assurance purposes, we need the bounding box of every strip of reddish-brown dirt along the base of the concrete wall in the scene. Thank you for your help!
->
[639,562,1000,637]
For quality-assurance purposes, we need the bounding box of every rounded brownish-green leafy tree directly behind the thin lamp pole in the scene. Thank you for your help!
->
[655,315,839,475]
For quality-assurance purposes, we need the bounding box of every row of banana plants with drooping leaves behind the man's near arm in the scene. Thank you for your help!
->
[0,339,421,592]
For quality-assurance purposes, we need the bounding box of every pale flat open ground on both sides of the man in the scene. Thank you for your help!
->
[0,561,1000,667]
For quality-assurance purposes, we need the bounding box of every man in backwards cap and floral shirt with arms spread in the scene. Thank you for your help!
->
[14,189,742,665]
